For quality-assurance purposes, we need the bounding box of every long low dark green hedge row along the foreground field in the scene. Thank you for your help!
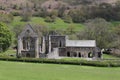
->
[0,57,120,67]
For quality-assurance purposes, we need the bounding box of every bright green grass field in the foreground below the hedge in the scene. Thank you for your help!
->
[0,61,120,80]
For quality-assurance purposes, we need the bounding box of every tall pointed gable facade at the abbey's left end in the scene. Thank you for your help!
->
[17,24,39,58]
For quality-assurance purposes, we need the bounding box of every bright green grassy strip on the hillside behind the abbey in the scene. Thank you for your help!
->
[10,16,83,31]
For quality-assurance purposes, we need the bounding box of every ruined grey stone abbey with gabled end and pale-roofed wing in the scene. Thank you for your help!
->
[17,24,99,59]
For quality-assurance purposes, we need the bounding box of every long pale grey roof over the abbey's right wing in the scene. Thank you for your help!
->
[66,40,96,47]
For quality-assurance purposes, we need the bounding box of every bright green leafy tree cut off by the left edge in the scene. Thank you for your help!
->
[0,22,12,52]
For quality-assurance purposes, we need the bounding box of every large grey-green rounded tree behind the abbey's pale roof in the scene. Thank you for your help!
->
[78,18,114,48]
